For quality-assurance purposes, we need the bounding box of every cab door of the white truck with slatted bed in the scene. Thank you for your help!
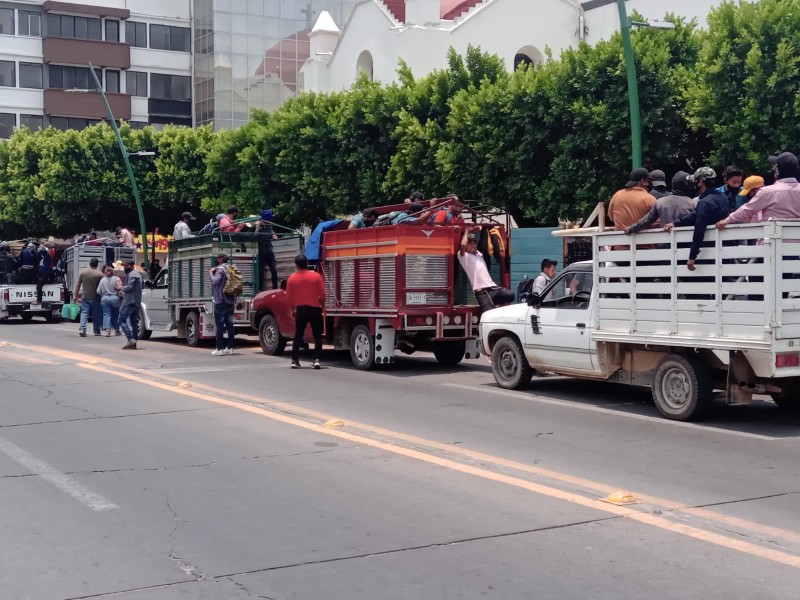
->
[525,271,594,371]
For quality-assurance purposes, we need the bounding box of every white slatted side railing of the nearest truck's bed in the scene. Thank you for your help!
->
[592,221,800,350]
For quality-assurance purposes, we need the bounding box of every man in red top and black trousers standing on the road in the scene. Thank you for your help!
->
[286,254,325,369]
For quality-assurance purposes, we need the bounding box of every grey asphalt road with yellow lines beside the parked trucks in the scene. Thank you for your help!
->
[0,321,800,600]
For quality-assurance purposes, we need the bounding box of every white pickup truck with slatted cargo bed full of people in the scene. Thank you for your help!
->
[480,221,800,421]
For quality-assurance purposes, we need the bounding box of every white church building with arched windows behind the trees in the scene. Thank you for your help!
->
[301,0,719,92]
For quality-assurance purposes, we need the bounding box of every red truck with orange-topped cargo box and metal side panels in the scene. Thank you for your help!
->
[251,201,509,370]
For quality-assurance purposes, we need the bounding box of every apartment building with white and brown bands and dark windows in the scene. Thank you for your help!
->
[0,0,193,138]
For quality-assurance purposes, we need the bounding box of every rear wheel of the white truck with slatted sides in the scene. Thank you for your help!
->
[652,354,714,421]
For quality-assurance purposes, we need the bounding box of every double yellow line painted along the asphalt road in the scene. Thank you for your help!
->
[9,346,800,568]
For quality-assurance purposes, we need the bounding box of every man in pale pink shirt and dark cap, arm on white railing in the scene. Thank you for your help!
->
[717,152,800,229]
